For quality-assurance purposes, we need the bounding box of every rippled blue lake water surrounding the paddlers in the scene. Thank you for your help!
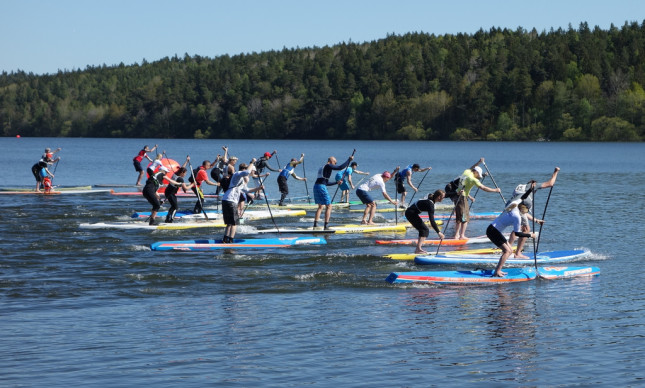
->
[0,138,645,387]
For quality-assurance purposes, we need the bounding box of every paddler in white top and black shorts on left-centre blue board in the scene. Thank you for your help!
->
[222,159,264,244]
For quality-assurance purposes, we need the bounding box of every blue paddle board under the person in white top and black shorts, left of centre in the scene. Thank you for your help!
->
[150,237,327,251]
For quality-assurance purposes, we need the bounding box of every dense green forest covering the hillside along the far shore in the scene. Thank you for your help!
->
[0,21,645,141]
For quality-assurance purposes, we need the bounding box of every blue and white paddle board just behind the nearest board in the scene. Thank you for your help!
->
[414,249,591,266]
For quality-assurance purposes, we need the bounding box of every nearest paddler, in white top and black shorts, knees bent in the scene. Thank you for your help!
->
[486,181,544,277]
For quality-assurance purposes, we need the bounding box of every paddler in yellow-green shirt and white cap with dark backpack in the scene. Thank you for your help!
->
[446,158,501,240]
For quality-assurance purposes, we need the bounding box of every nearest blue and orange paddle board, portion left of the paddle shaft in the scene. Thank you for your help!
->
[385,267,537,284]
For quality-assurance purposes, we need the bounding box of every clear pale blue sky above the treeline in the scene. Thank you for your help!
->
[0,0,645,74]
